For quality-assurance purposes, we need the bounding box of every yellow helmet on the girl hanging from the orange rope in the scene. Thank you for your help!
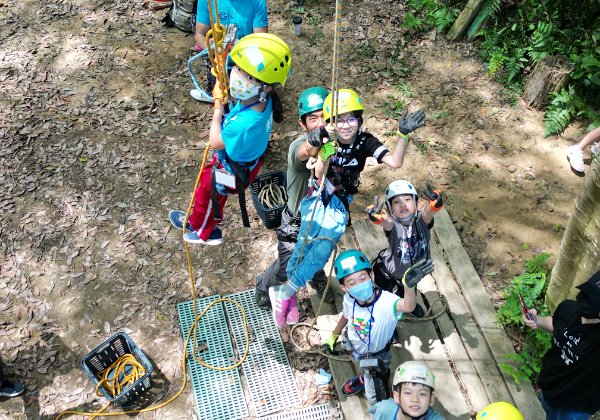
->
[229,33,292,86]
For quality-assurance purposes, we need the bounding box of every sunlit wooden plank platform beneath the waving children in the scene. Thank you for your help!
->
[311,210,544,420]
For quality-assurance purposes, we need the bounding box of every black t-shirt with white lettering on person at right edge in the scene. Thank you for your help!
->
[538,300,600,414]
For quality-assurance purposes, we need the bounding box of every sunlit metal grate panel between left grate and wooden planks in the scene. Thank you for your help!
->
[225,290,301,417]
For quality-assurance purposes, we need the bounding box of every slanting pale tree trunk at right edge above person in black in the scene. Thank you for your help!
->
[546,162,600,311]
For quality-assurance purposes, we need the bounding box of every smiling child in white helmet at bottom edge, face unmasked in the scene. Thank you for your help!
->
[369,361,444,420]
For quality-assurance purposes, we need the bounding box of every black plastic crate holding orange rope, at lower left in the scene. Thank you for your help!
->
[81,332,152,405]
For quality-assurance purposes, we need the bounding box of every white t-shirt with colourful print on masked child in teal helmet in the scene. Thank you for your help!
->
[342,290,403,355]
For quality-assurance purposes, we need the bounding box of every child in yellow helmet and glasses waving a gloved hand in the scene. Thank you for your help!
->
[315,89,425,217]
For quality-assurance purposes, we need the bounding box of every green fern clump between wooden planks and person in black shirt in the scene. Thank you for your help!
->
[496,253,551,384]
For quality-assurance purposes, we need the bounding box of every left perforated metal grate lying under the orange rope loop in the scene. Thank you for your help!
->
[177,295,248,420]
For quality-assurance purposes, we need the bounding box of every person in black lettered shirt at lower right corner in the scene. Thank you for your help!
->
[523,271,600,420]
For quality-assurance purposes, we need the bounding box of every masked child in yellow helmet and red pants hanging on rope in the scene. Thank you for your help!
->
[169,33,292,245]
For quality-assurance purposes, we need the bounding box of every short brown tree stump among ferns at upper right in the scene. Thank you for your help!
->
[523,56,573,110]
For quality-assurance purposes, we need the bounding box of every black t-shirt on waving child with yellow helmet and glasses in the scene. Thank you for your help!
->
[327,132,389,194]
